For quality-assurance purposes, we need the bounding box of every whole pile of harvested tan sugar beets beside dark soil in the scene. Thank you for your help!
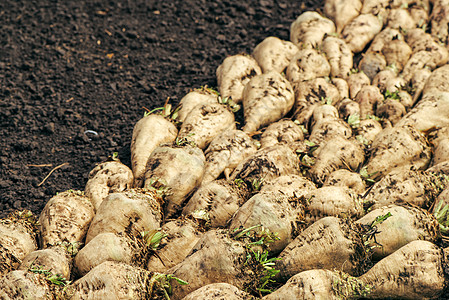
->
[4,0,449,300]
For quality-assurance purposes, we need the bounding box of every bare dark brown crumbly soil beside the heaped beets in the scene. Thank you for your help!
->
[0,0,322,217]
